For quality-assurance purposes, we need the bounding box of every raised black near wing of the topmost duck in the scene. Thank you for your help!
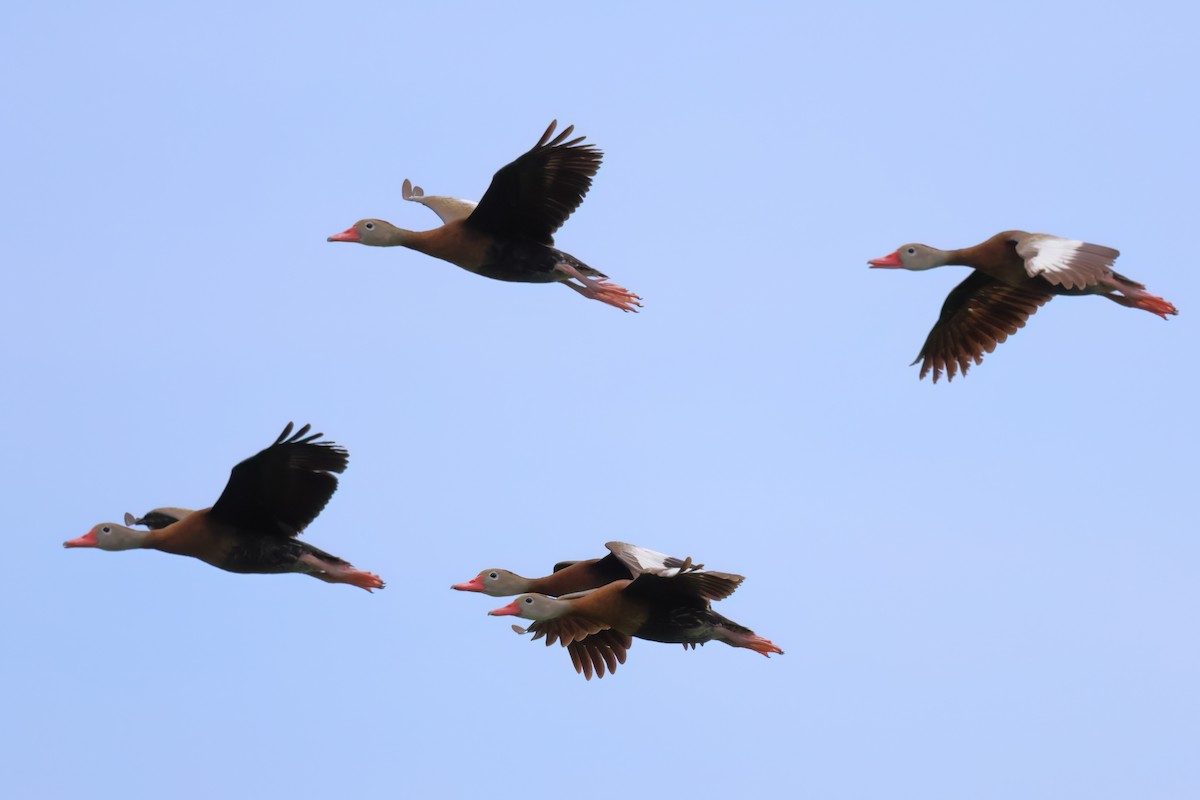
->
[463,120,604,245]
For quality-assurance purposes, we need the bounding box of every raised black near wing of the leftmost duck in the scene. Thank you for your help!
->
[209,422,349,536]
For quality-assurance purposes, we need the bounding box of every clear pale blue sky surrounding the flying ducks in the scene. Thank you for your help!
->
[0,0,1200,800]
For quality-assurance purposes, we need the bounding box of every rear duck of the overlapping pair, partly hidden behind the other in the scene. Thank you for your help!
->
[450,542,742,597]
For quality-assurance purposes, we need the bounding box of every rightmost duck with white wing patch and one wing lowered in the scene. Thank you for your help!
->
[868,230,1178,383]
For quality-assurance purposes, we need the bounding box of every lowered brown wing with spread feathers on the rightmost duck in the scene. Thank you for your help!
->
[913,270,1054,384]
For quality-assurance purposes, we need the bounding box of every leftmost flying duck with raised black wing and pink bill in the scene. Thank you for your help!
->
[62,422,383,591]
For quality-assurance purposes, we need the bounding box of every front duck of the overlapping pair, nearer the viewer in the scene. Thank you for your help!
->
[488,571,784,679]
